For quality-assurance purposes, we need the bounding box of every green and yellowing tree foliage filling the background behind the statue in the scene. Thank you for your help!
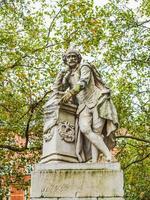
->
[0,0,150,200]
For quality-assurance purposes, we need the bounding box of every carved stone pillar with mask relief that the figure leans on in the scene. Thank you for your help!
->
[40,93,78,163]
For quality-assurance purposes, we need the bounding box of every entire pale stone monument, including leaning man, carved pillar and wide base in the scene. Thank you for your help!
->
[31,49,124,200]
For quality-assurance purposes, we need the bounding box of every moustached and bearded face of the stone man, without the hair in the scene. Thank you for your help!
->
[66,53,79,68]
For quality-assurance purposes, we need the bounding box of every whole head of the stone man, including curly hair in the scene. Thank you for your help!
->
[63,49,82,67]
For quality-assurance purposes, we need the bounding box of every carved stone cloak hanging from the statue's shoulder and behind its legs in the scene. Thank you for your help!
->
[75,63,118,162]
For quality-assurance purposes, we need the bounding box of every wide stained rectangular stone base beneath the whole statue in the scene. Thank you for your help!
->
[31,163,124,200]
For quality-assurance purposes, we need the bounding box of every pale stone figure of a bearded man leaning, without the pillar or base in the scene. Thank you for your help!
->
[49,49,118,162]
